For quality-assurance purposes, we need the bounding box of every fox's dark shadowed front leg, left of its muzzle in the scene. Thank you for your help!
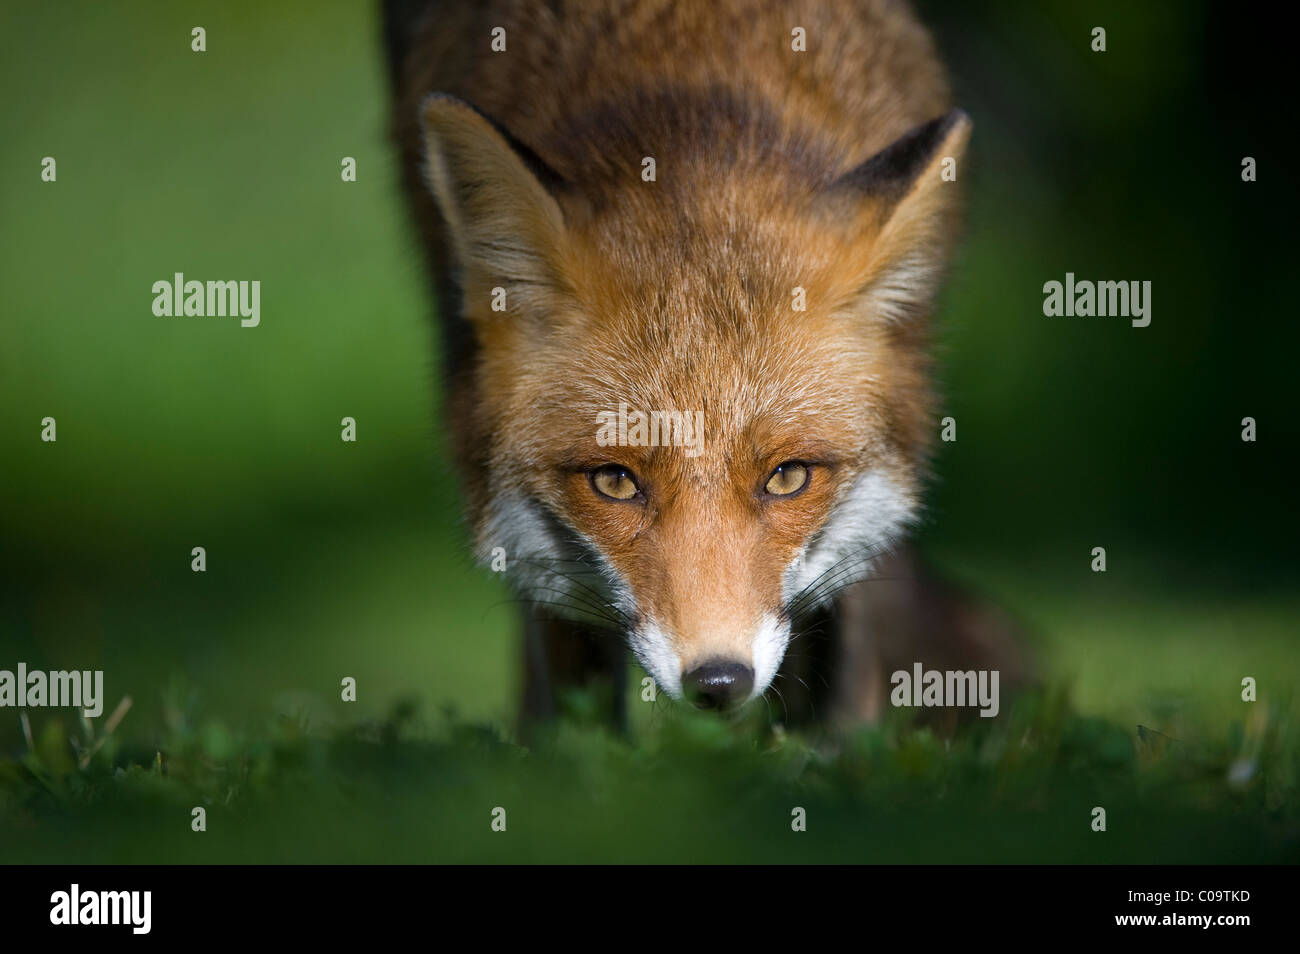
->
[520,610,627,737]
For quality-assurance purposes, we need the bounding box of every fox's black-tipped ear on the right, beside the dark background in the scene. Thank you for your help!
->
[831,109,971,317]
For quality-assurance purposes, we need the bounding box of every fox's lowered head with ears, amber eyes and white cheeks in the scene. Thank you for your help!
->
[424,95,970,706]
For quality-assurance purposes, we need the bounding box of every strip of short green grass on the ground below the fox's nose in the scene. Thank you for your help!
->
[0,670,1300,863]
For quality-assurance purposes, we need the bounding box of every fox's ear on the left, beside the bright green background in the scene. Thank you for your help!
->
[424,94,566,310]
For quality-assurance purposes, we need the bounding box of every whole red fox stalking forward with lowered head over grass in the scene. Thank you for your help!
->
[385,0,1029,720]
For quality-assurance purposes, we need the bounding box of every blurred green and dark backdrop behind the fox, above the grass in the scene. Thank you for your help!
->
[0,0,1300,858]
